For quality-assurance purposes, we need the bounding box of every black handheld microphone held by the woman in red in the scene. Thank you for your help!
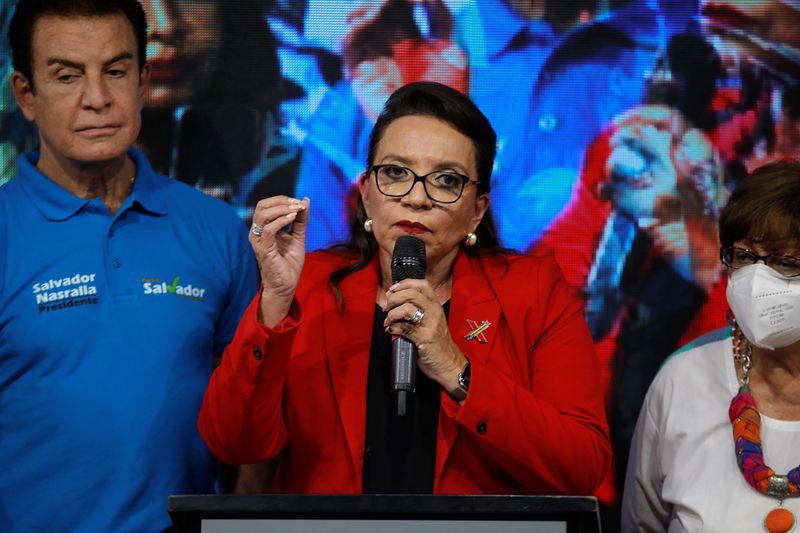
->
[392,235,426,416]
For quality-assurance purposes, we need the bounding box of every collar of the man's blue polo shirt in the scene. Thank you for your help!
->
[15,148,167,220]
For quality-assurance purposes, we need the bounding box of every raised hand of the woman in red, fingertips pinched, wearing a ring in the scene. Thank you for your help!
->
[250,196,310,327]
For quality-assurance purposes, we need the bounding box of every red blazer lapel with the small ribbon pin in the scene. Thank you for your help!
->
[434,252,500,482]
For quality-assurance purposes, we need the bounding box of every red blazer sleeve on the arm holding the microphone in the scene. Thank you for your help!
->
[443,258,611,494]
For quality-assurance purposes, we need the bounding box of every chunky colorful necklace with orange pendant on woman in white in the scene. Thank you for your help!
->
[728,320,800,533]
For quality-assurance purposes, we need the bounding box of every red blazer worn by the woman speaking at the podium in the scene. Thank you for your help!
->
[199,252,611,494]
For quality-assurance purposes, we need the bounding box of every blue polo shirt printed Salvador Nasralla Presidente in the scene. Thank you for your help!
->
[0,150,258,533]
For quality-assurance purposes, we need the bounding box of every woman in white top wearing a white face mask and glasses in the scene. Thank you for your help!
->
[622,162,800,532]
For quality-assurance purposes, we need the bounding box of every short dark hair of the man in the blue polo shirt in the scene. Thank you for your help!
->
[8,0,147,90]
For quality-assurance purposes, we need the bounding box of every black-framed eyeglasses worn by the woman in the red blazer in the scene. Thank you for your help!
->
[371,165,480,204]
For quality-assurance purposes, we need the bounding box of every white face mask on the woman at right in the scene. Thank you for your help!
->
[727,263,800,350]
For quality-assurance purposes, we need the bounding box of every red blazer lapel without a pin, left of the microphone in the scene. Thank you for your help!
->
[322,254,378,478]
